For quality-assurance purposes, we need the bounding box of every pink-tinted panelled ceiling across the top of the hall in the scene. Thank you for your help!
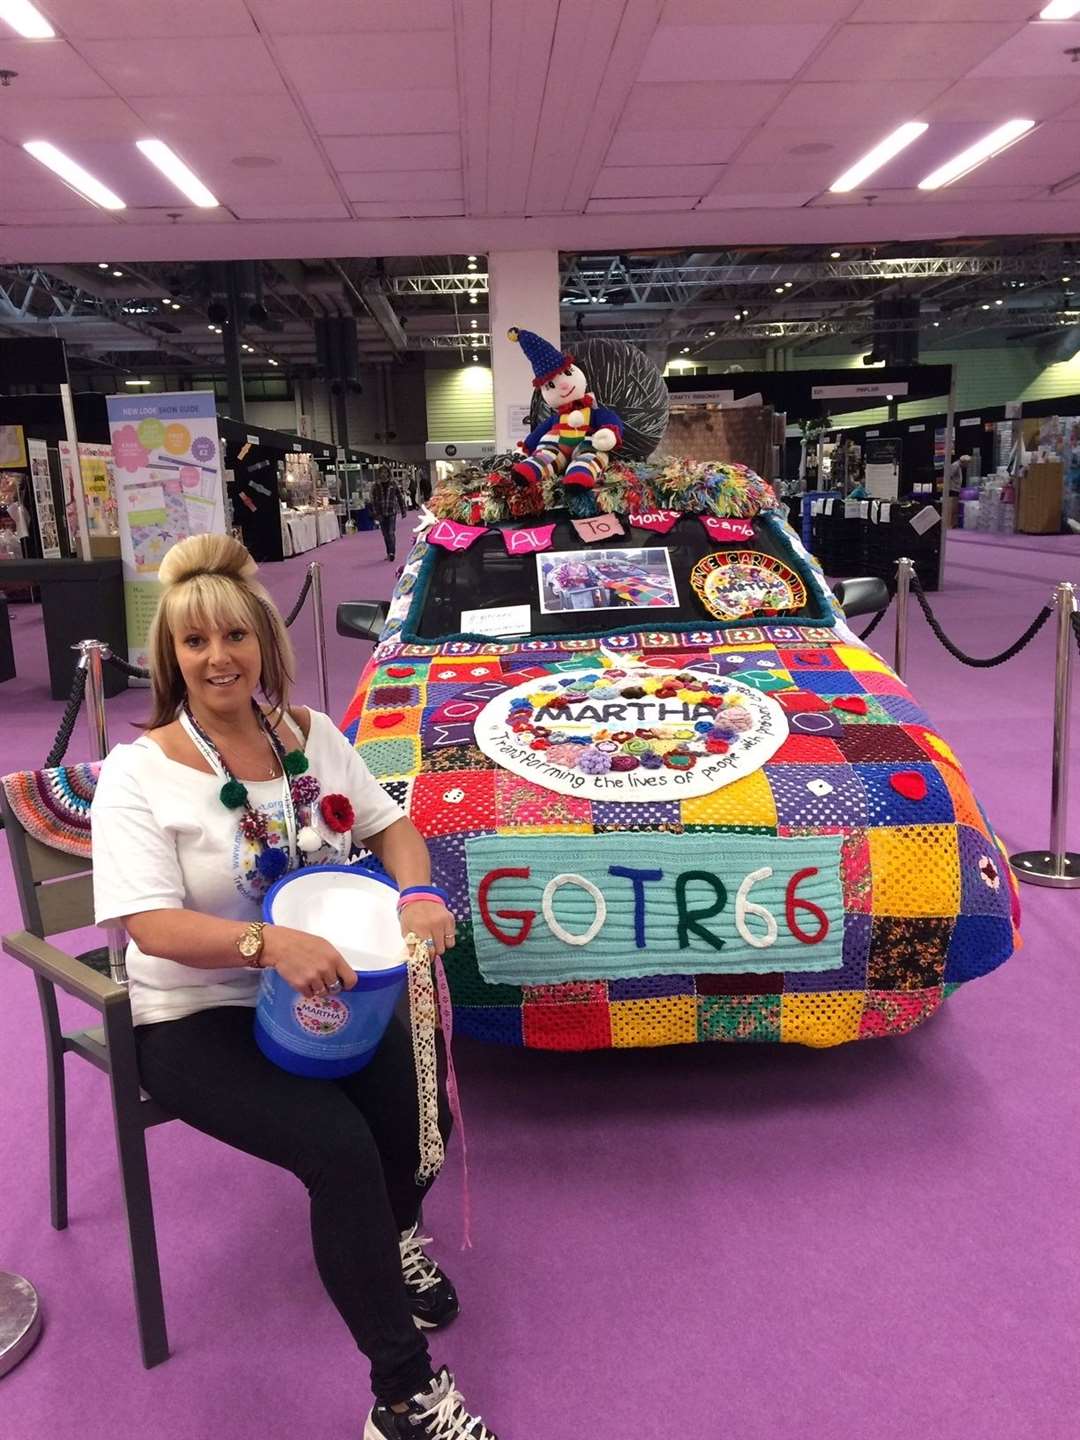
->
[0,0,1080,264]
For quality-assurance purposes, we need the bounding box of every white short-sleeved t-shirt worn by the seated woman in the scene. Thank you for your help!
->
[91,710,403,1025]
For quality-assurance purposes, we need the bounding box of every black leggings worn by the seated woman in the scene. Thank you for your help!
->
[135,1005,451,1404]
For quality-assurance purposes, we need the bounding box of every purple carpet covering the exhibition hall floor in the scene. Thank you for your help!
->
[0,520,1080,1440]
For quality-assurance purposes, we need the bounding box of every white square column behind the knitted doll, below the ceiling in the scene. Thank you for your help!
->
[489,251,560,454]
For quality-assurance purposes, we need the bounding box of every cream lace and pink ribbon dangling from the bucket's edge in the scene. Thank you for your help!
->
[405,930,472,1248]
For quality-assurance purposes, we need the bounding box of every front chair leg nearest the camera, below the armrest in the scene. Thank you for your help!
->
[105,999,168,1369]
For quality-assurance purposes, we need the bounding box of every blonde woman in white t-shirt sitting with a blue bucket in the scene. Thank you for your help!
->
[92,536,494,1440]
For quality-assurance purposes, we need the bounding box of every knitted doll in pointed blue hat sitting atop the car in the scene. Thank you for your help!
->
[507,328,622,490]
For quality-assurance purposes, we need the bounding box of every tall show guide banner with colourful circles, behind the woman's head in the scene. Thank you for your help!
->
[107,390,225,665]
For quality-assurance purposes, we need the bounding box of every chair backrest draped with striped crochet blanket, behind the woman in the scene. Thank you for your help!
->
[0,763,99,939]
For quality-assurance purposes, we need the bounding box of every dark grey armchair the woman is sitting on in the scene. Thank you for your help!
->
[0,766,173,1368]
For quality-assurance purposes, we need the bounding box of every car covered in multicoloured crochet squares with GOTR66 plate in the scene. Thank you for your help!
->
[344,464,1018,1050]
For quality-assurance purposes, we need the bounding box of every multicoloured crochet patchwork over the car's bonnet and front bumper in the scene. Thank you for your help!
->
[344,492,1020,1050]
